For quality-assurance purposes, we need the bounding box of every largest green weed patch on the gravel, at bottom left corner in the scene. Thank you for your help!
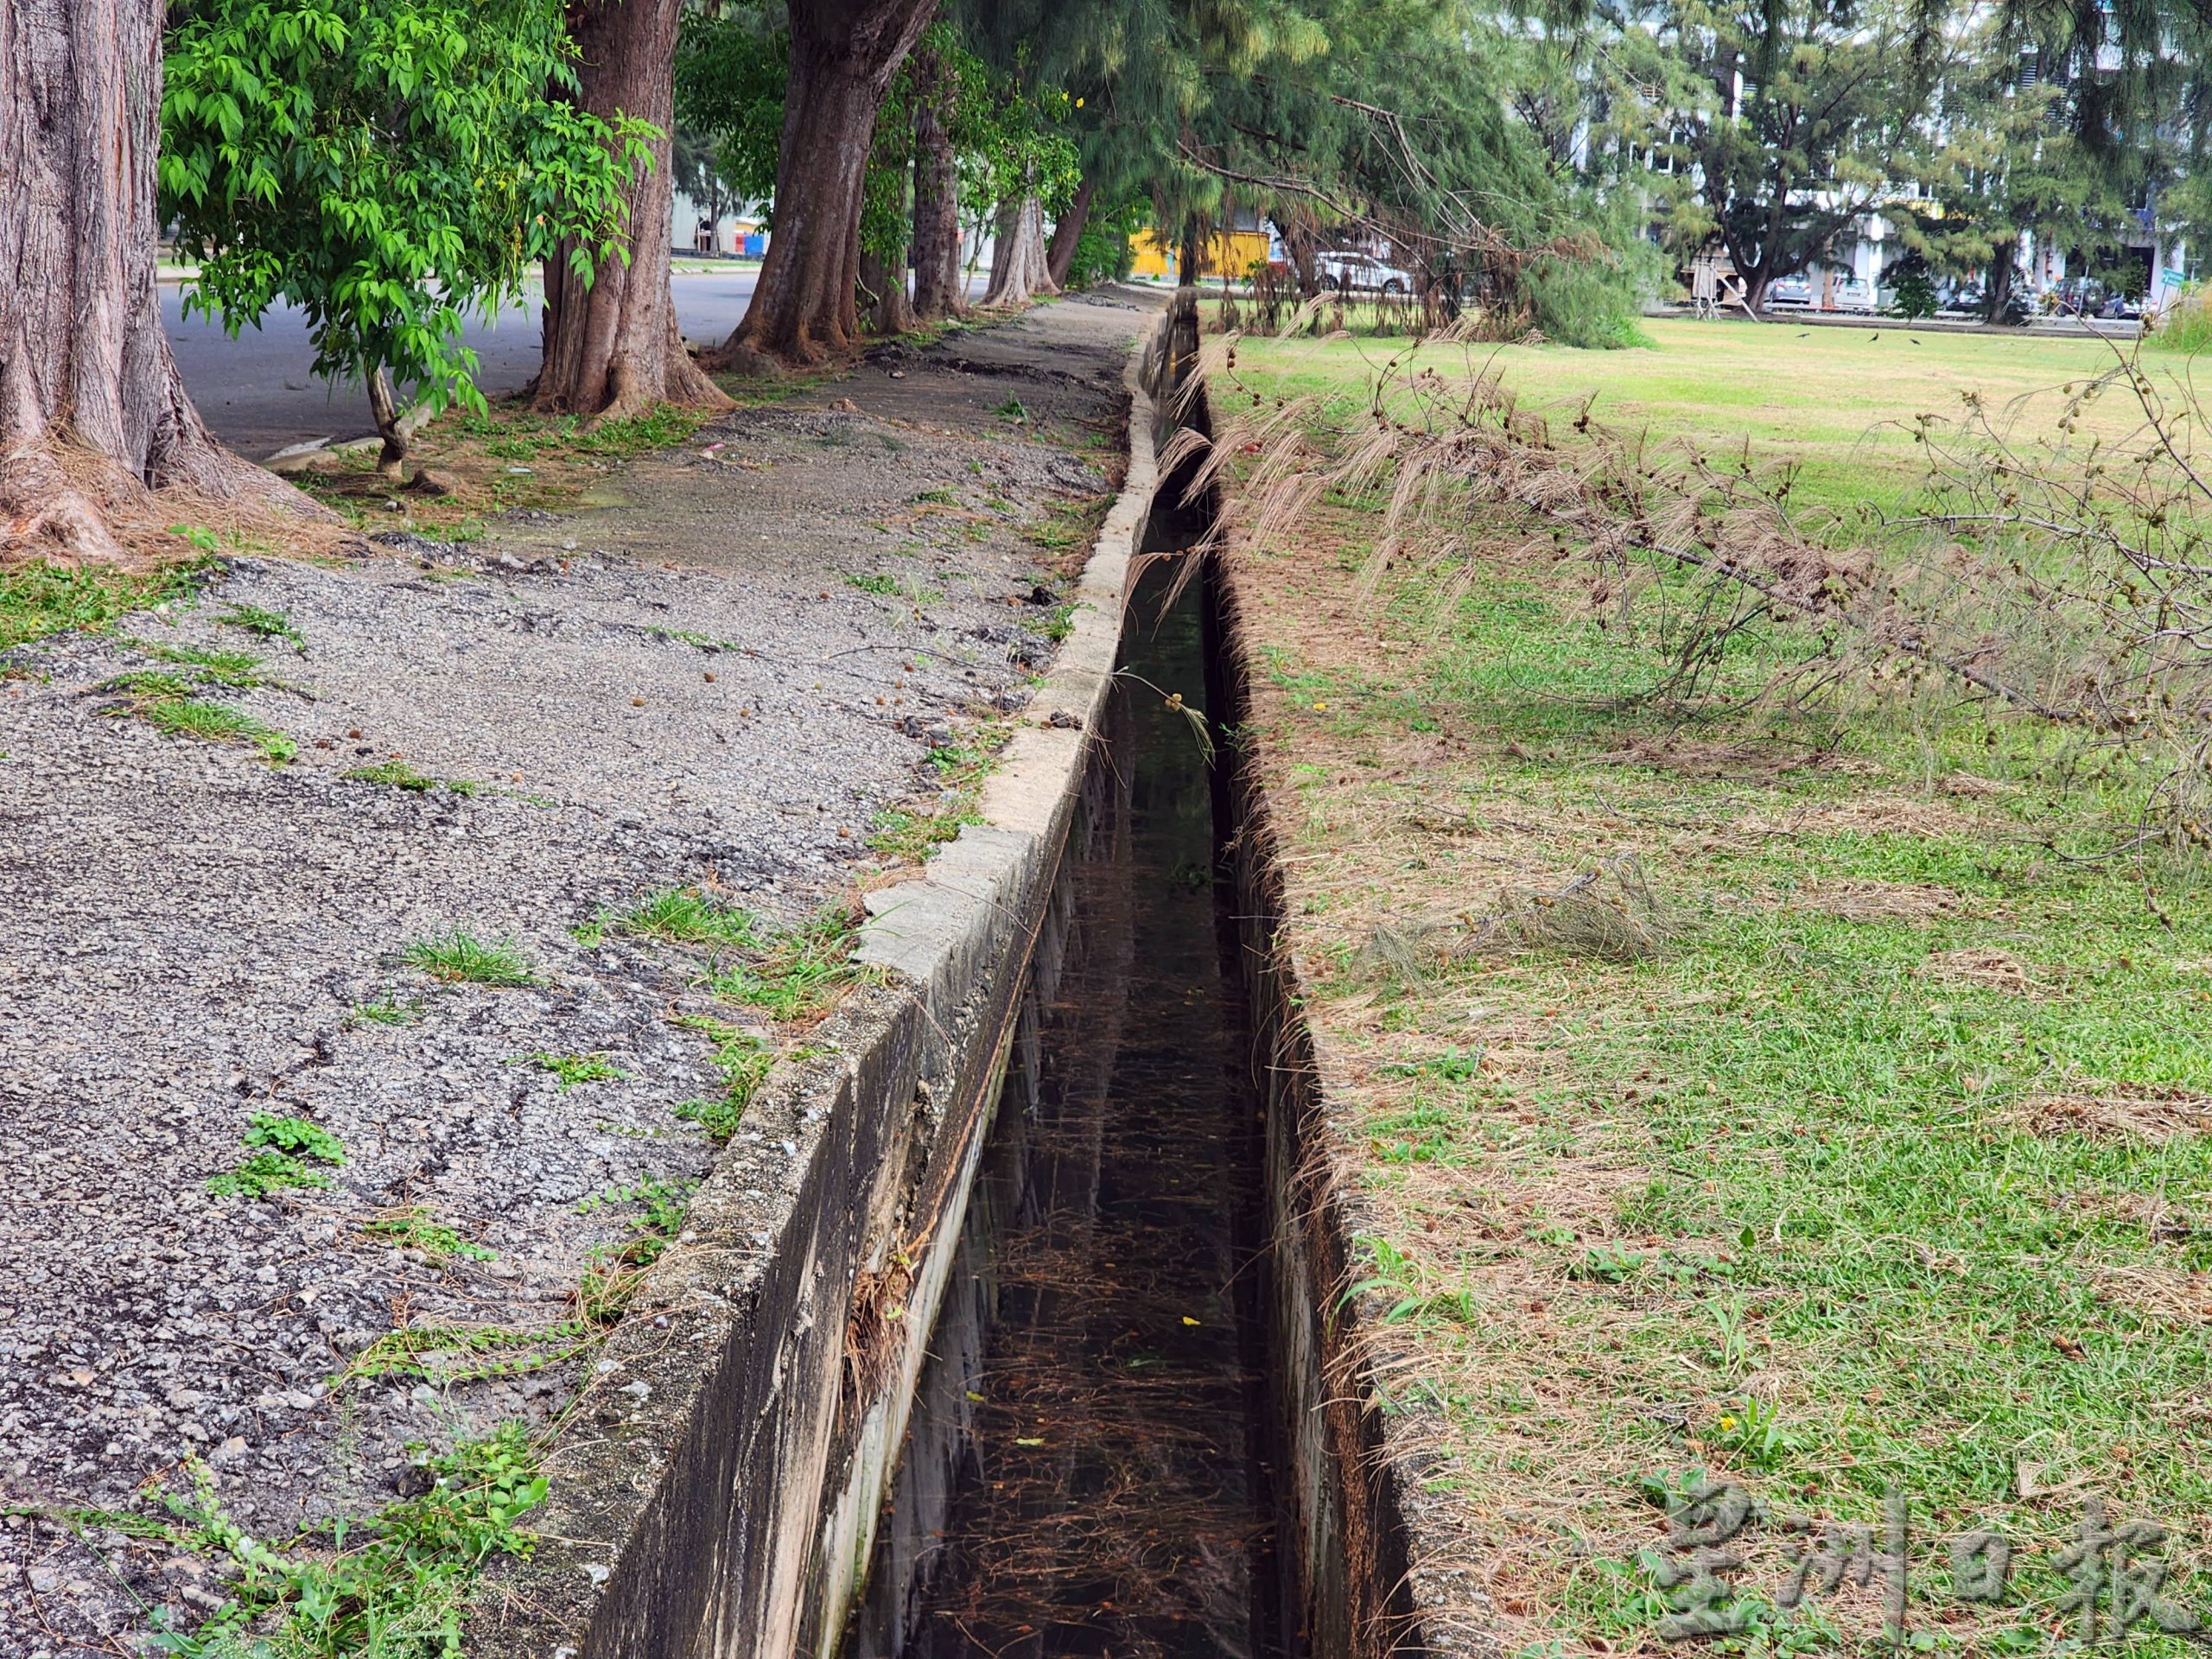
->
[153,1422,546,1659]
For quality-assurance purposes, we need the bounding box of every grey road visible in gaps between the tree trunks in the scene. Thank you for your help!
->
[162,265,982,460]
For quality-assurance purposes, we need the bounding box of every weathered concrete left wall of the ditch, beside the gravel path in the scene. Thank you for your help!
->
[467,314,1177,1659]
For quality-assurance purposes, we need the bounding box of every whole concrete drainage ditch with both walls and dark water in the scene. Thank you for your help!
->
[471,289,1421,1659]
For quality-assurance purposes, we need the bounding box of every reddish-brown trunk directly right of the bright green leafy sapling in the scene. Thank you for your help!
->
[536,0,730,420]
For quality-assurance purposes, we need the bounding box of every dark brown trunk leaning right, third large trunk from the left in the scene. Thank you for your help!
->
[721,0,936,372]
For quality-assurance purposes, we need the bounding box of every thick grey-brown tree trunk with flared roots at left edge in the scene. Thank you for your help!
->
[0,0,323,560]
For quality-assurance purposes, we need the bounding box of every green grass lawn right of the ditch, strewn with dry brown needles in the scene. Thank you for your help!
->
[1230,323,2212,1656]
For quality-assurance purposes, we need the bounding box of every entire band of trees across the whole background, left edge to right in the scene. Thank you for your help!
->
[13,0,2212,546]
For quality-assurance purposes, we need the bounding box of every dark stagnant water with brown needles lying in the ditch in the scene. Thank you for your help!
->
[905,555,1281,1659]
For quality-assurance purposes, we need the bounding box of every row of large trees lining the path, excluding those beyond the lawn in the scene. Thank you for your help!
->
[0,0,1626,550]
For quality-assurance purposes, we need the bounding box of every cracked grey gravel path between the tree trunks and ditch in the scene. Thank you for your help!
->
[0,301,1144,1659]
